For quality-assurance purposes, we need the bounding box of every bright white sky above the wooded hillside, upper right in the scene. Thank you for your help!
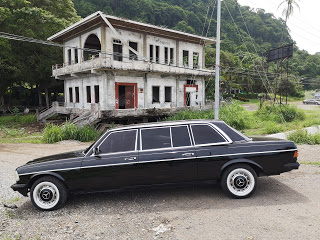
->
[238,0,320,54]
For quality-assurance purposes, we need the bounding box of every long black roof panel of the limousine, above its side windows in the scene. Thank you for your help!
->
[109,119,224,131]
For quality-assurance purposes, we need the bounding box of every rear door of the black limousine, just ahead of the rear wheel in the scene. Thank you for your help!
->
[190,123,232,180]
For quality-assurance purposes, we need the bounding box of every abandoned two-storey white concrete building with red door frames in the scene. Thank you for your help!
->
[40,11,215,124]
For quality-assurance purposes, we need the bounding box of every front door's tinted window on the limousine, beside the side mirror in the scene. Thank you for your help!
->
[100,130,137,153]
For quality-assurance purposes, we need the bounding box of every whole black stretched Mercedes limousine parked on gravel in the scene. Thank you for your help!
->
[11,120,299,210]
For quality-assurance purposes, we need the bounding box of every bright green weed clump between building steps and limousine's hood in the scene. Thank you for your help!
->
[43,123,99,143]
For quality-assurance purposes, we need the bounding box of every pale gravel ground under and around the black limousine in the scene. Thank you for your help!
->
[0,142,320,240]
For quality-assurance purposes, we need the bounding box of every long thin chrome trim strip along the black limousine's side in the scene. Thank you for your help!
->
[19,148,298,176]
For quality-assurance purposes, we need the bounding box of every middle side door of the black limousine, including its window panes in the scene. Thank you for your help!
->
[139,125,197,184]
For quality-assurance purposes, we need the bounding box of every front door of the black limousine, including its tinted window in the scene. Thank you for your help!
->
[81,129,139,191]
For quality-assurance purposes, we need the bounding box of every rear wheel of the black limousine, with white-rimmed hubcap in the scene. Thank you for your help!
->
[221,164,258,198]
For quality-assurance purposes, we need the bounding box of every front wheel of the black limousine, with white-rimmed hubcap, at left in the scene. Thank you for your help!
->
[30,176,68,211]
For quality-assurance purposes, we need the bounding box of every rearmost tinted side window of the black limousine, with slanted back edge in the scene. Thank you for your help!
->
[191,124,226,144]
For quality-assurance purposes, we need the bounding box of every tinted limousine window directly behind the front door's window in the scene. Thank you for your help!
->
[141,127,171,150]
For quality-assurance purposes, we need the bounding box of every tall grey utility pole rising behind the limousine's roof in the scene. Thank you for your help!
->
[214,0,221,120]
